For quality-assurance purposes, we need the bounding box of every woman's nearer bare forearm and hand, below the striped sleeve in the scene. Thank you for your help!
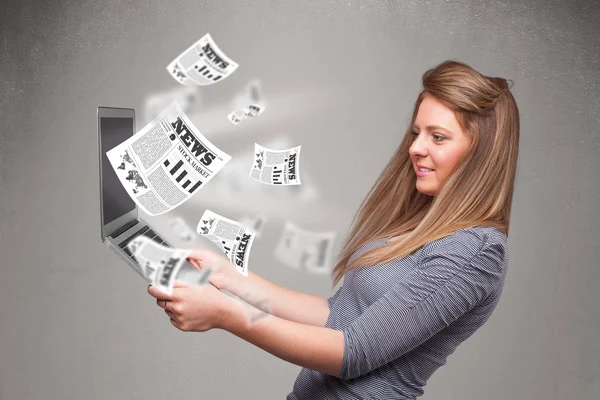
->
[148,280,344,375]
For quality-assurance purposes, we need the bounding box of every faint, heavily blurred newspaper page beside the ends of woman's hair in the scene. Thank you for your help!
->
[274,221,336,274]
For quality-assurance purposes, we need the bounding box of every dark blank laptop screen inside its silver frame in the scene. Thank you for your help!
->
[100,117,135,225]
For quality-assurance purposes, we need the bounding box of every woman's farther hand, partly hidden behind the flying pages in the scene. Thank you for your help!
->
[188,249,242,292]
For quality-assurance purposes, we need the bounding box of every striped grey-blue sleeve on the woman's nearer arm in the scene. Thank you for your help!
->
[337,237,505,379]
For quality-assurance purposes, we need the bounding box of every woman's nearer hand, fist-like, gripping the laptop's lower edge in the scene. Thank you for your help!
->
[148,278,237,332]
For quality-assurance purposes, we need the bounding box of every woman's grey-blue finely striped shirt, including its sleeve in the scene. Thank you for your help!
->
[287,227,508,400]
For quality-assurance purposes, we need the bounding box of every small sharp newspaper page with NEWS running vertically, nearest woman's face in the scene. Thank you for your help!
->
[250,143,302,185]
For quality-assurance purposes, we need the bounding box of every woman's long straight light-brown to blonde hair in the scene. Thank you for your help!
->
[332,60,519,286]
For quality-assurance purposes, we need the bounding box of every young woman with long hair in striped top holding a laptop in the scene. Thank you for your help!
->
[148,61,519,400]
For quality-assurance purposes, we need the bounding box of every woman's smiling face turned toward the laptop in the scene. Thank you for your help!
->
[408,96,470,196]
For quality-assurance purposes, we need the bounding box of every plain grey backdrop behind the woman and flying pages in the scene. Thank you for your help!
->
[0,0,600,400]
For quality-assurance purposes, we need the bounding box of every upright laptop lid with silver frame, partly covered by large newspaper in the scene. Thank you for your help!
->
[98,107,138,239]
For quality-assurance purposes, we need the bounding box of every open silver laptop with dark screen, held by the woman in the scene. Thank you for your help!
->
[98,107,210,285]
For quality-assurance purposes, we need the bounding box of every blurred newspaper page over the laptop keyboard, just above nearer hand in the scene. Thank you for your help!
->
[127,236,190,294]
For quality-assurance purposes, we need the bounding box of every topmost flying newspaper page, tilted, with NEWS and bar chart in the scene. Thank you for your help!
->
[167,33,238,86]
